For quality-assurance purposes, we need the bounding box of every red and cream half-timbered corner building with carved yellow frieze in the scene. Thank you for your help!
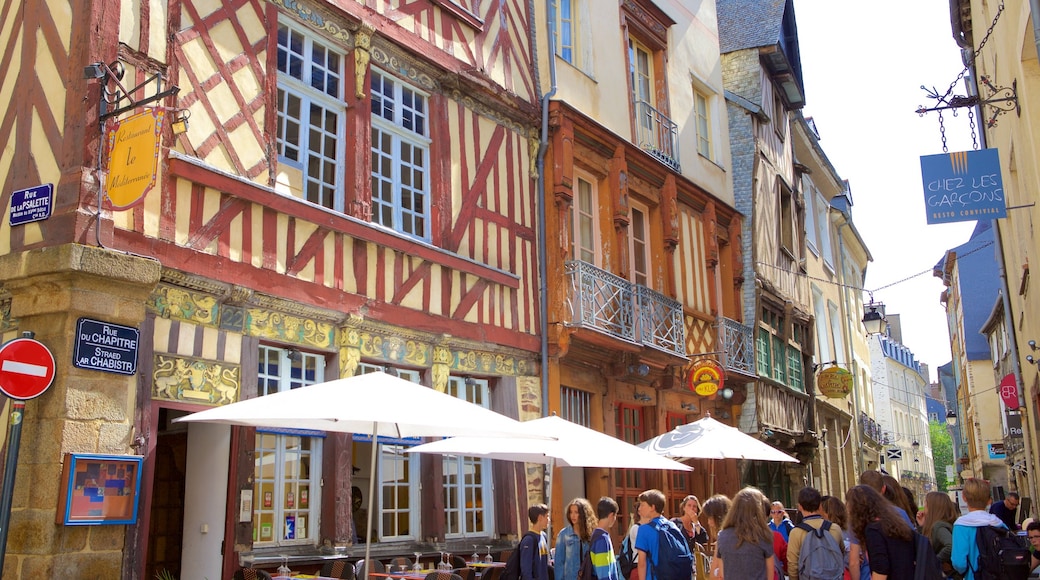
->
[0,0,544,578]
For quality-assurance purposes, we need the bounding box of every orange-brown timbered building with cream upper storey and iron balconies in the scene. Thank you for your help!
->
[537,0,753,542]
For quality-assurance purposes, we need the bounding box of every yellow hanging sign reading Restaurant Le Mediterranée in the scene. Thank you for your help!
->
[105,109,162,210]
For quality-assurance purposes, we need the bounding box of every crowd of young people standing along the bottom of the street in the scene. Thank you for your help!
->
[511,470,1040,580]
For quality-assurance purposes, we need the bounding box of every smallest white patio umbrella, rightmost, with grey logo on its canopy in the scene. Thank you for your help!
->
[639,415,799,494]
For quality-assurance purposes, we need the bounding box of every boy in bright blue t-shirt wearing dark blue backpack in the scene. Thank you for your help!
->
[635,490,694,580]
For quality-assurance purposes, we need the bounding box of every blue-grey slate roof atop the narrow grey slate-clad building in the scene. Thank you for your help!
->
[716,0,787,54]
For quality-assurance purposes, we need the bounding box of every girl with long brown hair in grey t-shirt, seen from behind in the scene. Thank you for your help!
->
[712,487,774,580]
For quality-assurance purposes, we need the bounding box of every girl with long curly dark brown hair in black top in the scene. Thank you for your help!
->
[846,485,915,580]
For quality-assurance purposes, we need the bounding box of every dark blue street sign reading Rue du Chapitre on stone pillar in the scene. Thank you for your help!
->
[72,318,140,374]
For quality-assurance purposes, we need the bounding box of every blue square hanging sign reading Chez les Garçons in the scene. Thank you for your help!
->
[920,149,1008,223]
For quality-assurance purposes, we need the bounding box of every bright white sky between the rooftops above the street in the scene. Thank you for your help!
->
[795,0,981,380]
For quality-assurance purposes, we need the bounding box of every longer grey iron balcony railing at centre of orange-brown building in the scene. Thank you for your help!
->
[564,260,686,357]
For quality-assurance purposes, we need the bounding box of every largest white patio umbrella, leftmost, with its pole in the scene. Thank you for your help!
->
[175,372,543,573]
